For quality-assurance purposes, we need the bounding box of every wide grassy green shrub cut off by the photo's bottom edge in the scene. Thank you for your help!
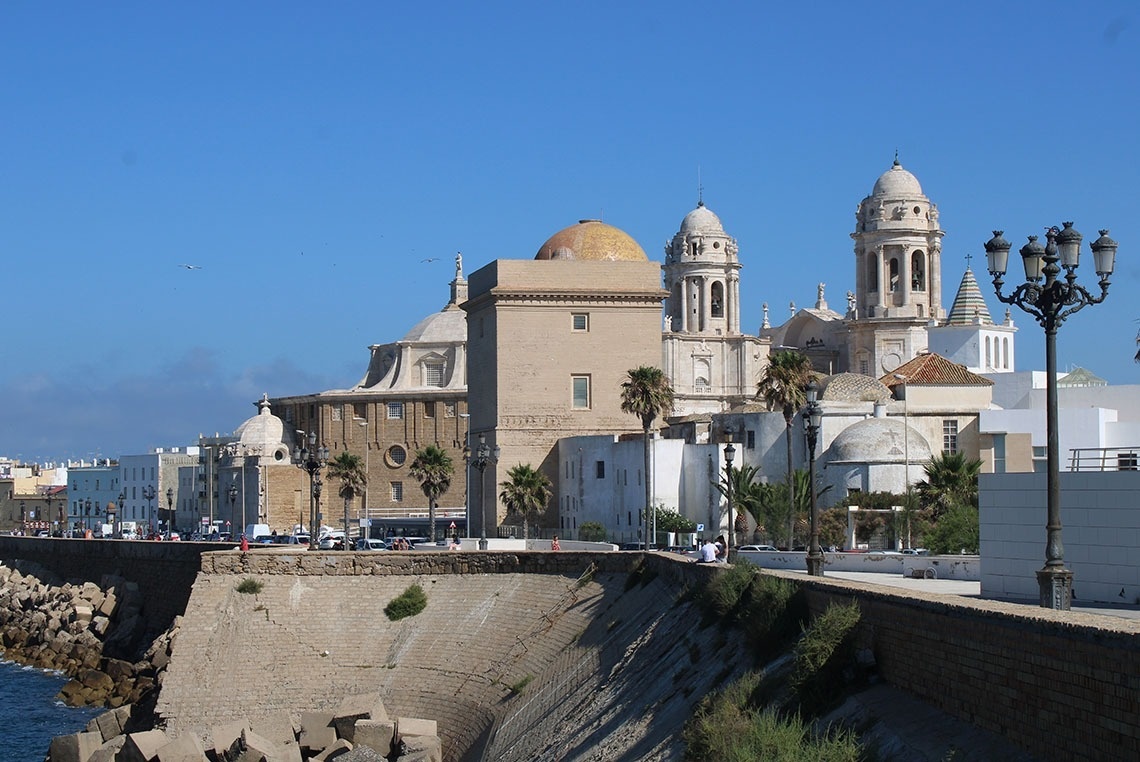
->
[682,672,862,762]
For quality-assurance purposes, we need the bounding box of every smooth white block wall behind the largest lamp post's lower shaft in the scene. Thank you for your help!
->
[979,471,1140,603]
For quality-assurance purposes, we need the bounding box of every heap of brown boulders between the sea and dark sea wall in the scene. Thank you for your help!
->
[0,564,177,707]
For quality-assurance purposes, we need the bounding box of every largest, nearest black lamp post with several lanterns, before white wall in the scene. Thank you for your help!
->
[985,222,1117,610]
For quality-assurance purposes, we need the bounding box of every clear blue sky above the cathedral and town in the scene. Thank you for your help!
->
[0,0,1140,461]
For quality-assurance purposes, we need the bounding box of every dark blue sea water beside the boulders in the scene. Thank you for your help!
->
[0,662,104,762]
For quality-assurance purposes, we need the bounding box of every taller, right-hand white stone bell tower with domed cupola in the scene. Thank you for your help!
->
[847,155,946,376]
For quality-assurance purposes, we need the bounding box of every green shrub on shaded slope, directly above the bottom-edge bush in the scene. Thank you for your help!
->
[789,600,860,718]
